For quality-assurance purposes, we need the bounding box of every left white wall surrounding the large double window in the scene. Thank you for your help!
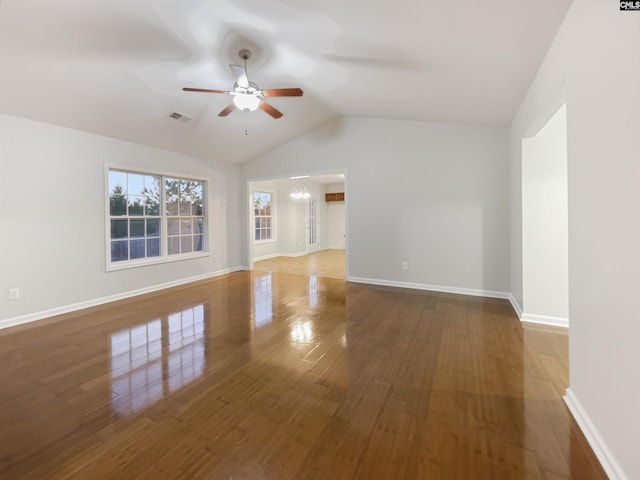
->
[0,115,246,324]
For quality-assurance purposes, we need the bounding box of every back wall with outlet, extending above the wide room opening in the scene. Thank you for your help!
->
[244,119,509,293]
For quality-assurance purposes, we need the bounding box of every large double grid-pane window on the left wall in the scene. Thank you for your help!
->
[108,169,206,266]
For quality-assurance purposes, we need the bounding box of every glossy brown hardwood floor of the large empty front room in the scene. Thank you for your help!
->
[0,271,606,480]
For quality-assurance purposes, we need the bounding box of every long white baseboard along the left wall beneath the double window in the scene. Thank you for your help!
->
[0,267,248,330]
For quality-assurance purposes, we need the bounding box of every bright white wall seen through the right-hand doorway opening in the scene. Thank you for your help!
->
[522,105,569,326]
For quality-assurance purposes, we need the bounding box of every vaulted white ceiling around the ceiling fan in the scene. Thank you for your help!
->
[0,0,571,162]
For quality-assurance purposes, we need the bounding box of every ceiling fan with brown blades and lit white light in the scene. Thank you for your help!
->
[182,48,302,118]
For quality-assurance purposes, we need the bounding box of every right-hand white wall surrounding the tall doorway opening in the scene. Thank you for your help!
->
[511,0,640,478]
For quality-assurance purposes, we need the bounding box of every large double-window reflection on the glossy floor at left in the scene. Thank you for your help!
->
[111,305,205,415]
